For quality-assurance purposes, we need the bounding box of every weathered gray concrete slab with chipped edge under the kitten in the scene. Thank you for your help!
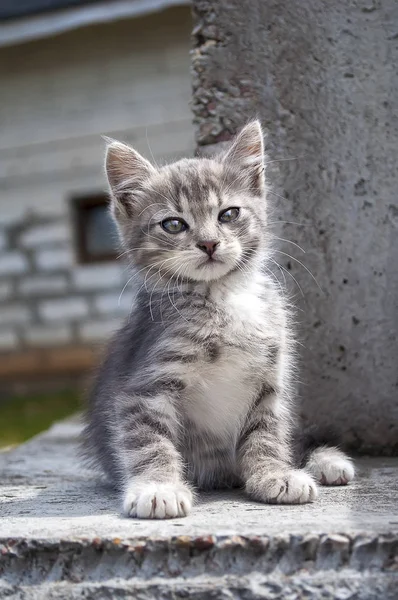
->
[0,423,398,600]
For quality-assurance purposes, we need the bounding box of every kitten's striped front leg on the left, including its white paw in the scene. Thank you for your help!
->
[118,394,192,519]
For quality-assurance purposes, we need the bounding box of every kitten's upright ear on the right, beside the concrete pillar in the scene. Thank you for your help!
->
[222,120,265,193]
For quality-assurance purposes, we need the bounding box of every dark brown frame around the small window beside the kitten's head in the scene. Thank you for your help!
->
[71,192,119,265]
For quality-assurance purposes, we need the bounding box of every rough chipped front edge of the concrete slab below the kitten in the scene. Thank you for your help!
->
[0,532,398,584]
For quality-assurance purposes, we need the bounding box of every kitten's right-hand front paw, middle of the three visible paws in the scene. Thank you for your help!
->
[248,470,318,504]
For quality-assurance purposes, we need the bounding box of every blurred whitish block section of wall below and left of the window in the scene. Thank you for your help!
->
[0,213,131,351]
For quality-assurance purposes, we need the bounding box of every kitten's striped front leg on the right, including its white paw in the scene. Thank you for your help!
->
[237,389,318,504]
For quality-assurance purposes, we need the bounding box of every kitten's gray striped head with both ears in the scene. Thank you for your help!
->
[106,121,266,281]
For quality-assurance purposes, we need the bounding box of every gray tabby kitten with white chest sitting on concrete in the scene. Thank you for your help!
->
[85,121,354,519]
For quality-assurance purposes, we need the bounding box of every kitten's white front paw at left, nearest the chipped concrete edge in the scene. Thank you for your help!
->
[123,483,192,519]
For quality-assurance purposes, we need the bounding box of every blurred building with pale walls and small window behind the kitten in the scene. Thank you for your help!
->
[0,0,194,388]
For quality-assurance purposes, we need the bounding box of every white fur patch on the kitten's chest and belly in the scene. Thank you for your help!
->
[186,282,280,438]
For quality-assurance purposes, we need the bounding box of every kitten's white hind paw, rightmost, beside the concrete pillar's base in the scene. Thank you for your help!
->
[306,448,355,485]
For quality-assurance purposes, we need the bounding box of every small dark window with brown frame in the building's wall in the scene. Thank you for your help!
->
[73,195,119,263]
